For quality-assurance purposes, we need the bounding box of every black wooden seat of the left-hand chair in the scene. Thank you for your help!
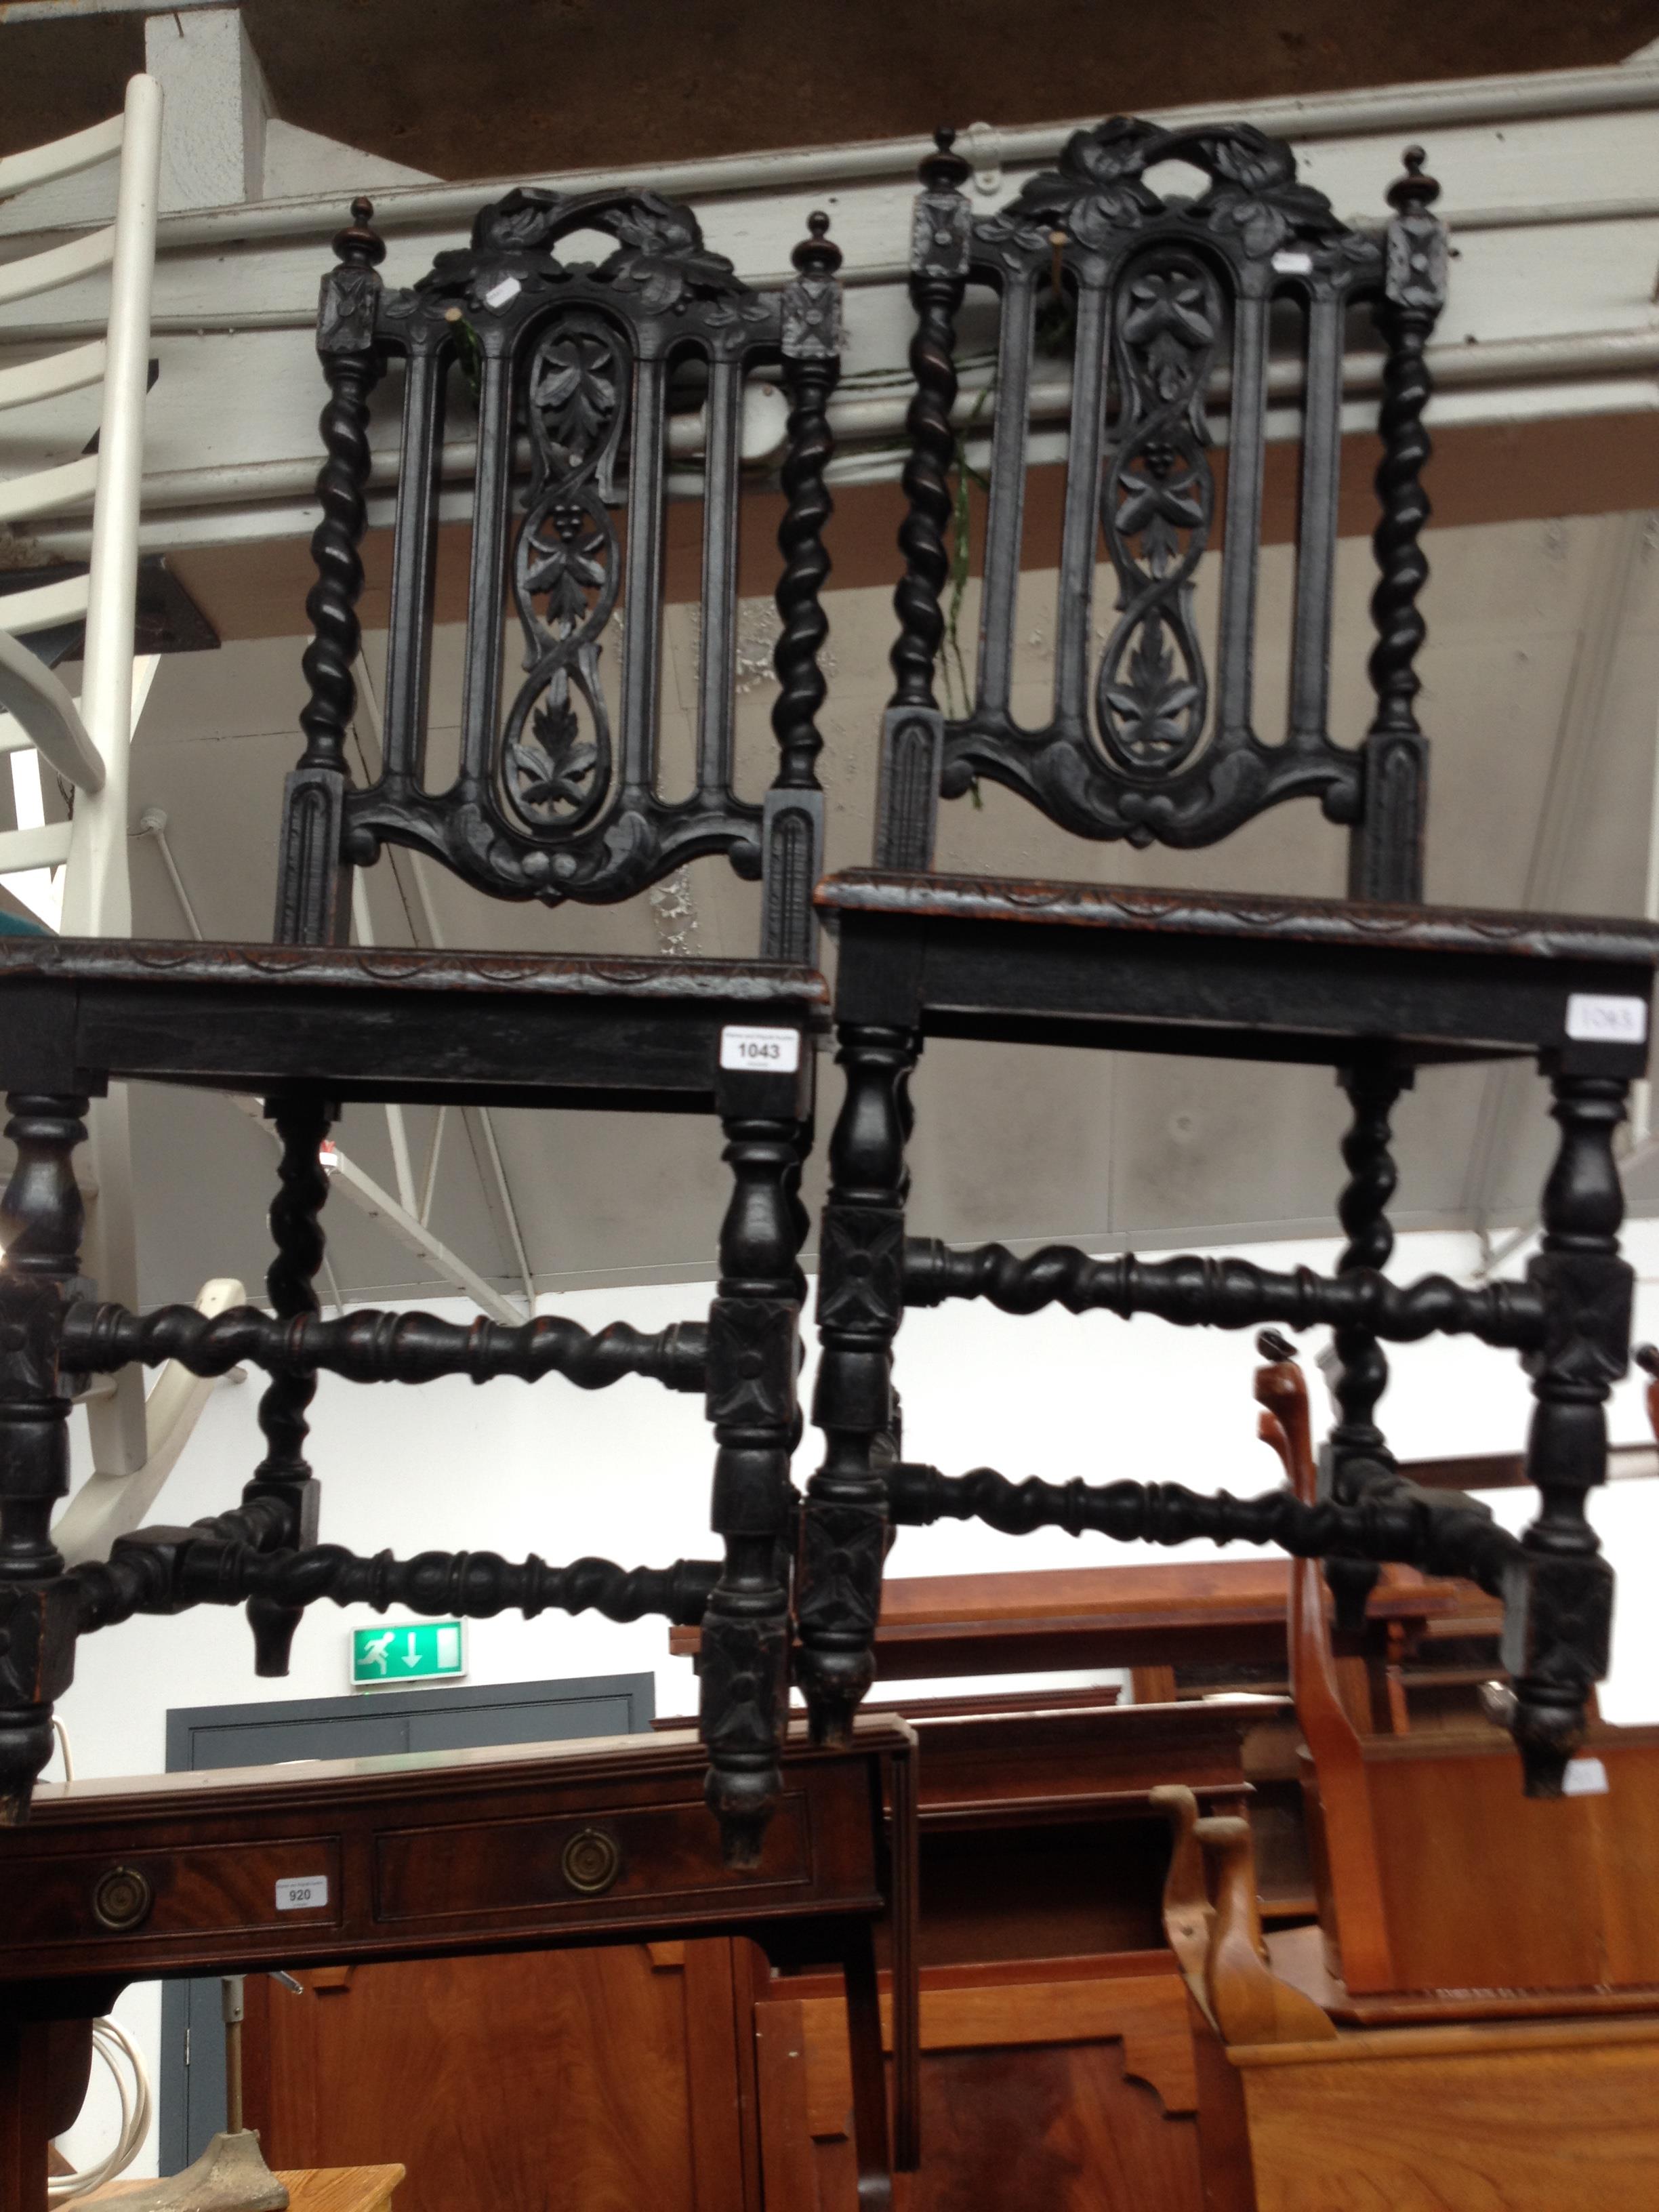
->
[0,938,830,1113]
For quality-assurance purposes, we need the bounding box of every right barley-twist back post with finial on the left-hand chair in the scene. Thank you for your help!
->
[761,210,840,962]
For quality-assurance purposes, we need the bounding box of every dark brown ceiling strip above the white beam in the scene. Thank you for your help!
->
[0,0,1659,177]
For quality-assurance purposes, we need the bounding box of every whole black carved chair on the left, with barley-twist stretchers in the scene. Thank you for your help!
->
[0,190,840,1865]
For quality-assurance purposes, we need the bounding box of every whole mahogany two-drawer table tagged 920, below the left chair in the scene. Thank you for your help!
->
[0,1715,916,2212]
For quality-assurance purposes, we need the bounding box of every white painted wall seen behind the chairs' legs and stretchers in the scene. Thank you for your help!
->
[48,1223,1659,2172]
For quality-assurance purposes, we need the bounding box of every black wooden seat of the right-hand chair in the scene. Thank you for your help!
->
[816,869,1659,1073]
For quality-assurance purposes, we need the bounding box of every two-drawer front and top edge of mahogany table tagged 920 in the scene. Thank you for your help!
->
[0,1717,912,1982]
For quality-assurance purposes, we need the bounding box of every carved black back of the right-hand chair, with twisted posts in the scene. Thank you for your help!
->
[876,115,1444,900]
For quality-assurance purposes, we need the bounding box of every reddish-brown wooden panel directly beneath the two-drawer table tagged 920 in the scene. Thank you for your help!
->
[245,1940,743,2212]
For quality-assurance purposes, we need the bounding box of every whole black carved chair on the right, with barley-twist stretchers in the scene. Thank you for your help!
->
[796,117,1659,1794]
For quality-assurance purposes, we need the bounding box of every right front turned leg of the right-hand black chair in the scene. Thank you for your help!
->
[1504,1071,1635,1796]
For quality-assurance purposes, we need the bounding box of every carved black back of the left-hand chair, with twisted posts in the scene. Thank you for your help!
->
[276,190,840,960]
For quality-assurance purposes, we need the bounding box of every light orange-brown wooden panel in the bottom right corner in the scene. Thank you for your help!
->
[1243,2024,1659,2212]
